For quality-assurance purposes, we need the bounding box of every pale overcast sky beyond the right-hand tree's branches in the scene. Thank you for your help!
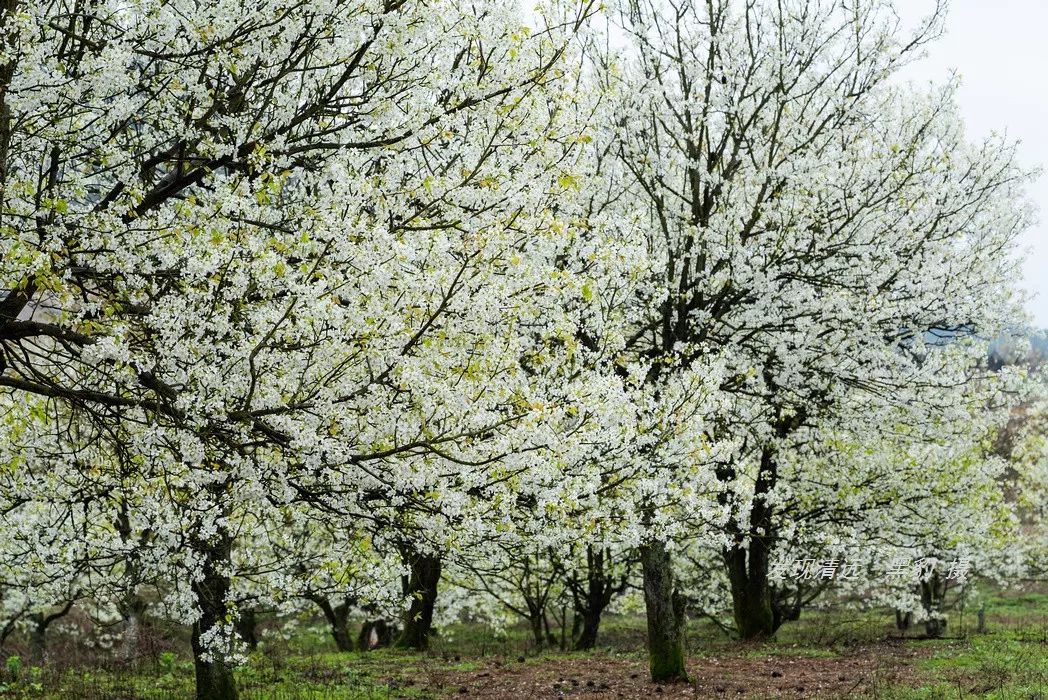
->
[897,0,1048,328]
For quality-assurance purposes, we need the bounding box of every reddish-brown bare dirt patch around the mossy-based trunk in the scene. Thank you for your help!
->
[391,640,923,700]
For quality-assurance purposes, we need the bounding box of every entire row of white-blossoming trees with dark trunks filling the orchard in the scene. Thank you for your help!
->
[0,0,1041,700]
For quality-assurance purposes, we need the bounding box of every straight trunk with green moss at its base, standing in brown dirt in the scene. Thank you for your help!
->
[640,542,687,683]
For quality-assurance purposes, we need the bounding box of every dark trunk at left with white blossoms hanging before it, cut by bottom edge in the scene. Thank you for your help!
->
[190,537,237,700]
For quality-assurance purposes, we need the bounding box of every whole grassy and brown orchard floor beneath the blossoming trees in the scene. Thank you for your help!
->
[0,585,1048,700]
